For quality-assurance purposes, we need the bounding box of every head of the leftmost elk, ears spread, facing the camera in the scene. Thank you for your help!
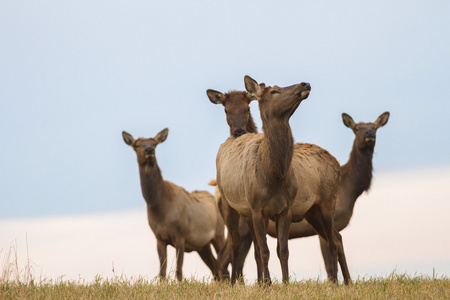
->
[122,128,169,165]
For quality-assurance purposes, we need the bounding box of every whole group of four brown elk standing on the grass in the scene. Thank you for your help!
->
[122,76,389,285]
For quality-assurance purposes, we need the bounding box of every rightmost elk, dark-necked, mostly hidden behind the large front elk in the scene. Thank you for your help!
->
[268,112,389,283]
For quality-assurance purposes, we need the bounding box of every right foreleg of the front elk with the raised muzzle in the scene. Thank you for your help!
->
[276,210,292,283]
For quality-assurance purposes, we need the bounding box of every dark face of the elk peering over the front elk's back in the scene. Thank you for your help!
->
[206,90,253,137]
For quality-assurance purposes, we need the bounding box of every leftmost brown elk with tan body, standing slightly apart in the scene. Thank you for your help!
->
[122,128,225,280]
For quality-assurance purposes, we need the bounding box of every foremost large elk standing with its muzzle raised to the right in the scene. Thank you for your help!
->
[211,76,340,282]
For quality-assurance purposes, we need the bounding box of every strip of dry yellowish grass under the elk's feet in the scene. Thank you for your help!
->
[0,273,450,300]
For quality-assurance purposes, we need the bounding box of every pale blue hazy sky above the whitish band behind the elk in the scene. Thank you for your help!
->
[0,0,450,219]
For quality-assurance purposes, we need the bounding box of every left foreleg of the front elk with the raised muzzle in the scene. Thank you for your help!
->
[252,212,272,285]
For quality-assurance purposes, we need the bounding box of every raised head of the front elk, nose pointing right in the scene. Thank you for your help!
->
[244,76,311,119]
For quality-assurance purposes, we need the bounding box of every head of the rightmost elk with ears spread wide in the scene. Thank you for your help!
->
[342,112,389,150]
